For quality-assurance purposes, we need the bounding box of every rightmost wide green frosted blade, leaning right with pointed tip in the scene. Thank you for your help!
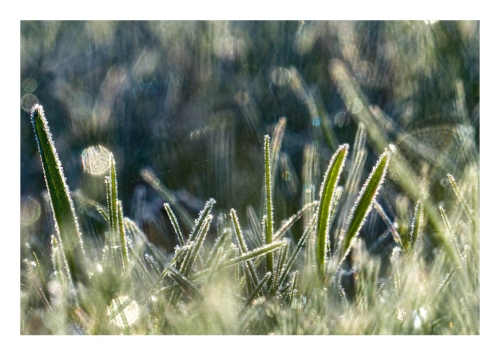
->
[340,150,390,257]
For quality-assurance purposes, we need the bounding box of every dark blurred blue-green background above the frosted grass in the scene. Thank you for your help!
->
[20,21,479,250]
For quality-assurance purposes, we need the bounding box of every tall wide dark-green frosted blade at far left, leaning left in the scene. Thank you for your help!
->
[31,105,86,282]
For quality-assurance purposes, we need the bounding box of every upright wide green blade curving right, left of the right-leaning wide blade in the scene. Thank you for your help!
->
[316,144,349,278]
